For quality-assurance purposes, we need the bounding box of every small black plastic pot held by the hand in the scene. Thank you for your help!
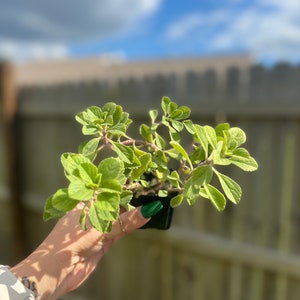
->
[130,195,174,230]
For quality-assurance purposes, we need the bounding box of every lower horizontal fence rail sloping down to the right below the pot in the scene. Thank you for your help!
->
[139,226,300,279]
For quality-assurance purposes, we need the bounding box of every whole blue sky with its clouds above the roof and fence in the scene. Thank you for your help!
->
[0,0,300,65]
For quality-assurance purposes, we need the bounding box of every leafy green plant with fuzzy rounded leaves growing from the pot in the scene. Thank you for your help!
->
[44,97,258,232]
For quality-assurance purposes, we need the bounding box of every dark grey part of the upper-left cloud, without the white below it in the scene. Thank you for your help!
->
[0,0,160,43]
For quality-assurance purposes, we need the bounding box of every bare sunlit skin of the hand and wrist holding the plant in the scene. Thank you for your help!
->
[11,208,149,300]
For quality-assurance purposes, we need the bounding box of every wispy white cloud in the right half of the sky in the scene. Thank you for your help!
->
[166,0,300,62]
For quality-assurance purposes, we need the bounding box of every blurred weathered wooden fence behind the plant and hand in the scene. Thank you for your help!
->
[0,64,300,300]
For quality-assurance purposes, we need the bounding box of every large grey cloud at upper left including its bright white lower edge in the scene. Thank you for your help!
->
[0,0,161,60]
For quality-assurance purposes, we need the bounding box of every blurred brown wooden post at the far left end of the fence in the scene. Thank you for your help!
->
[0,62,26,261]
